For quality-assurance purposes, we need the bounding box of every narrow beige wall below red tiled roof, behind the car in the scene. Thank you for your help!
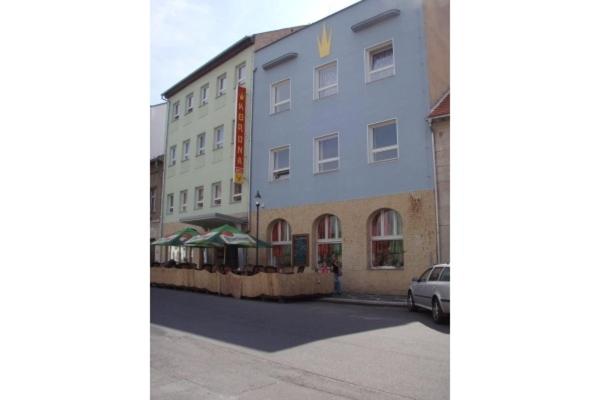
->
[432,118,450,263]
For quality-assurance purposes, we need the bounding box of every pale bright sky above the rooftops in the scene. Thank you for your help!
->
[150,0,357,105]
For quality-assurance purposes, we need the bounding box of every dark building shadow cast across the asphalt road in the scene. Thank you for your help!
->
[150,287,450,352]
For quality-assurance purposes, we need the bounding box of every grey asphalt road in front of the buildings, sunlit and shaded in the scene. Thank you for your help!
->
[151,288,450,400]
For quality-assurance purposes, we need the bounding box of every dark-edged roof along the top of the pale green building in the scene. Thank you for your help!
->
[162,25,303,99]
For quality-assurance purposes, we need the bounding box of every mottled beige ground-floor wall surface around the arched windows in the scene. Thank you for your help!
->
[248,191,436,294]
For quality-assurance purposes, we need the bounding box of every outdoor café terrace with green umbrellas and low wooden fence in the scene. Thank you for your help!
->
[150,225,334,299]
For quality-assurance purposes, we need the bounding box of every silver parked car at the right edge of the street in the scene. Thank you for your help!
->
[408,264,450,323]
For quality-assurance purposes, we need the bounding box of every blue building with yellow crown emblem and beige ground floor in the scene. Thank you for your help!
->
[251,0,450,293]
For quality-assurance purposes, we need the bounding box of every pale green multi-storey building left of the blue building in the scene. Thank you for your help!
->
[159,28,297,262]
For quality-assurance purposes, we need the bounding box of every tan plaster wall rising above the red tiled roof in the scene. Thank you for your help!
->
[423,0,450,105]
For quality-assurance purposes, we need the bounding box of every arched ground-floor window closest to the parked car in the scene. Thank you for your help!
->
[371,209,404,268]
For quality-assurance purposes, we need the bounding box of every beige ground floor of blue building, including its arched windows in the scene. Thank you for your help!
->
[248,191,437,294]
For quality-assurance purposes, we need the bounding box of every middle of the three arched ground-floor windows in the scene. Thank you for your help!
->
[316,214,342,268]
